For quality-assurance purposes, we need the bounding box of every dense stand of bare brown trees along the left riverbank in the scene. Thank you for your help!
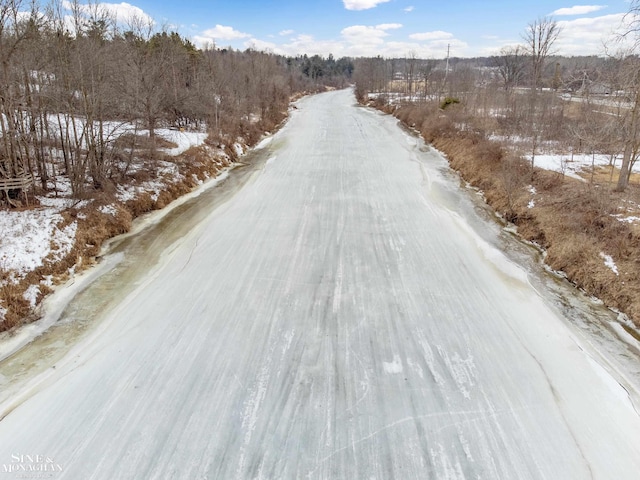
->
[0,0,353,203]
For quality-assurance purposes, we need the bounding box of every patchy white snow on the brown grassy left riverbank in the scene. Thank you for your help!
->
[0,127,211,321]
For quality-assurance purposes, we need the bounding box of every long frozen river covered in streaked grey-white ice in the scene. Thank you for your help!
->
[0,91,640,479]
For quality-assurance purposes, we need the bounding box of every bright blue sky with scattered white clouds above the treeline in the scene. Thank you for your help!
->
[63,0,629,58]
